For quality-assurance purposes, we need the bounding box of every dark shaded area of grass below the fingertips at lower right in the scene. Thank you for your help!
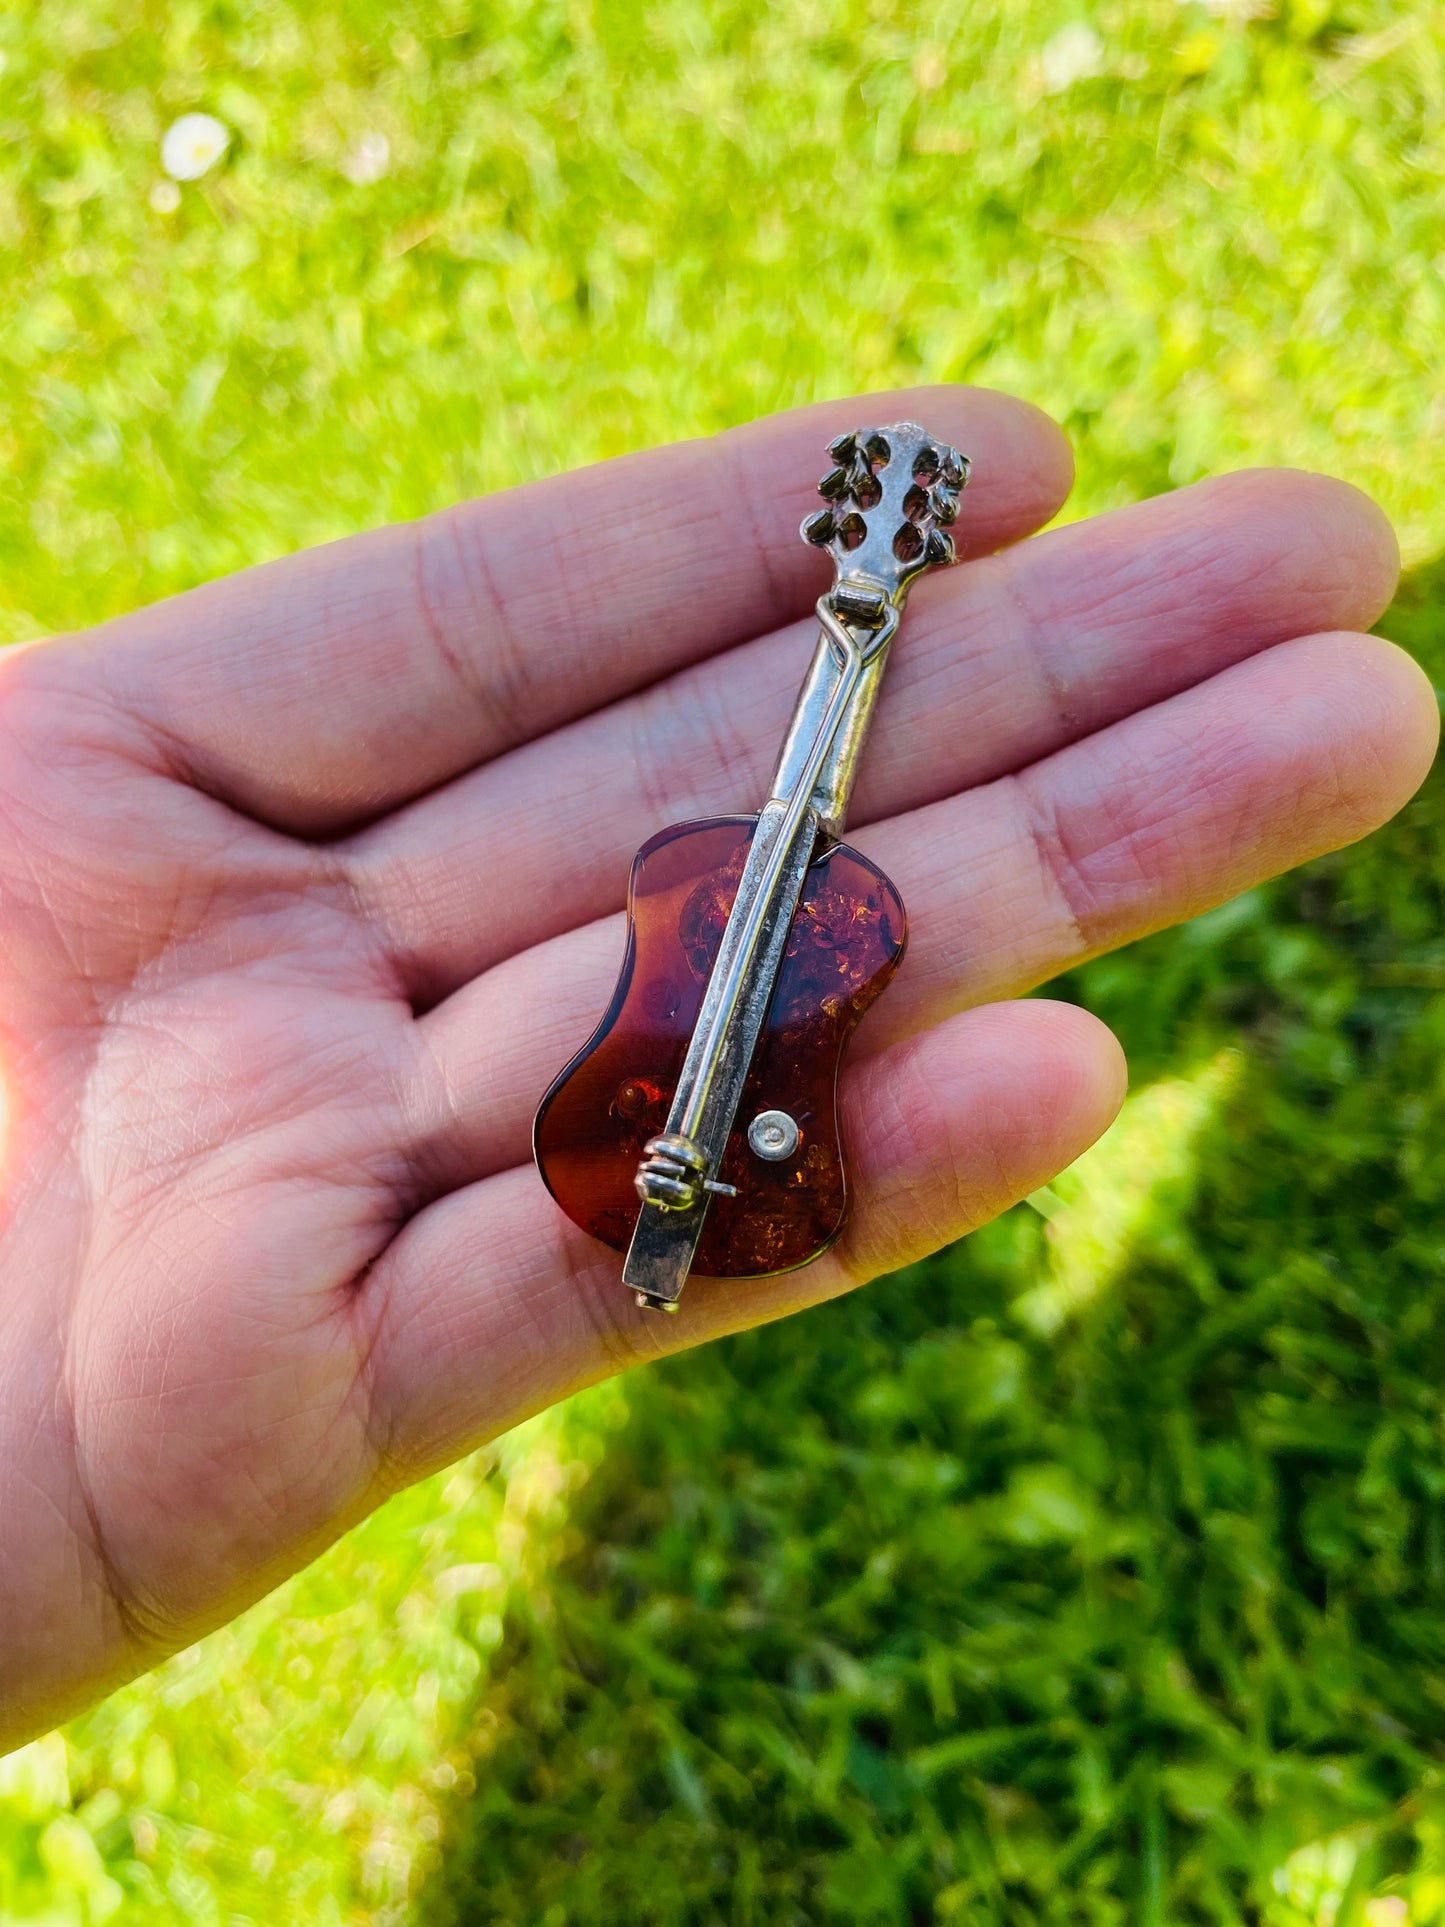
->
[422,563,1445,1927]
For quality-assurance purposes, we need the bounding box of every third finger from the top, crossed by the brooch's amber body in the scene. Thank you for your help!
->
[404,636,1437,1185]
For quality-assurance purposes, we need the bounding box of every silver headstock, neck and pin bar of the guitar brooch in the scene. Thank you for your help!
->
[622,422,969,1308]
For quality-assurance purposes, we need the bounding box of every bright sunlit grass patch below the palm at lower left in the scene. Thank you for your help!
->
[0,1414,616,1927]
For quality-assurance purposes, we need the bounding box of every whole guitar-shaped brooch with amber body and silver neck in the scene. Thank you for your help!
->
[534,422,969,1310]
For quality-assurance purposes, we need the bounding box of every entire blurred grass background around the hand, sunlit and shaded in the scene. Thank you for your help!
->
[0,0,1445,1927]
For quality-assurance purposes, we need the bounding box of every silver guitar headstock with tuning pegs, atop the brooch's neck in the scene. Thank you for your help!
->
[803,422,969,617]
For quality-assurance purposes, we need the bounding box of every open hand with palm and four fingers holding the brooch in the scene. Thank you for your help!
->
[0,387,1435,1750]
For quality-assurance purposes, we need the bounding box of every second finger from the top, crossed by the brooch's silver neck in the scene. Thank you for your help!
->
[347,470,1399,1002]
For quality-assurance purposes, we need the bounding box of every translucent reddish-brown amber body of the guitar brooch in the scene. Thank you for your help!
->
[536,817,906,1278]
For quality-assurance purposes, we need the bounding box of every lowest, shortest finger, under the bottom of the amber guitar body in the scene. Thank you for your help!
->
[362,1002,1125,1482]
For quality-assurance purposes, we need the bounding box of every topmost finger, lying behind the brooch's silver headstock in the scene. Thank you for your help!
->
[64,387,1073,834]
